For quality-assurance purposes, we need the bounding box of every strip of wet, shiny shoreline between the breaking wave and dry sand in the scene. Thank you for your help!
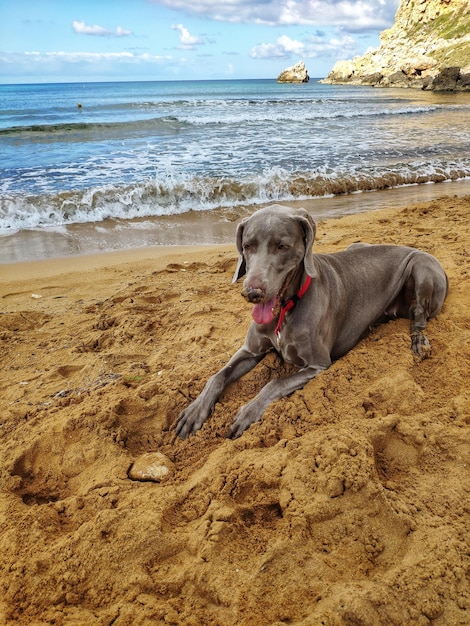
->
[0,179,470,264]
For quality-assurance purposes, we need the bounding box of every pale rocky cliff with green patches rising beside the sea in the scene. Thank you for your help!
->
[322,0,470,91]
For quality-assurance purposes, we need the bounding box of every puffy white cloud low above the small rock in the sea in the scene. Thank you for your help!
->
[250,34,356,59]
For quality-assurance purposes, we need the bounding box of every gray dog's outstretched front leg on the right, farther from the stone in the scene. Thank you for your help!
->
[227,367,325,439]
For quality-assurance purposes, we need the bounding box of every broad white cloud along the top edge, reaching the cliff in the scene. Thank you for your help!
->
[150,0,399,32]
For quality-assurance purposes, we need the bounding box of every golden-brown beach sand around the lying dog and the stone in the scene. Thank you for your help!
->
[0,196,470,626]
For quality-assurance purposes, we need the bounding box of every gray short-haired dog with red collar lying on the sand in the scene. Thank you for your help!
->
[176,205,448,439]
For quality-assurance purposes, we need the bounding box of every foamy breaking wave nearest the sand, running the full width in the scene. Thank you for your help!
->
[0,162,470,234]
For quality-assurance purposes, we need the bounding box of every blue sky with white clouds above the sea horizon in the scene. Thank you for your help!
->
[0,0,399,84]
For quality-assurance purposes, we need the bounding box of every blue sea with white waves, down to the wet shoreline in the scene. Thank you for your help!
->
[0,79,470,263]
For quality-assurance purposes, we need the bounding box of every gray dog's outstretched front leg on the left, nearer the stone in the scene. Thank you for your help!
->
[176,346,266,439]
